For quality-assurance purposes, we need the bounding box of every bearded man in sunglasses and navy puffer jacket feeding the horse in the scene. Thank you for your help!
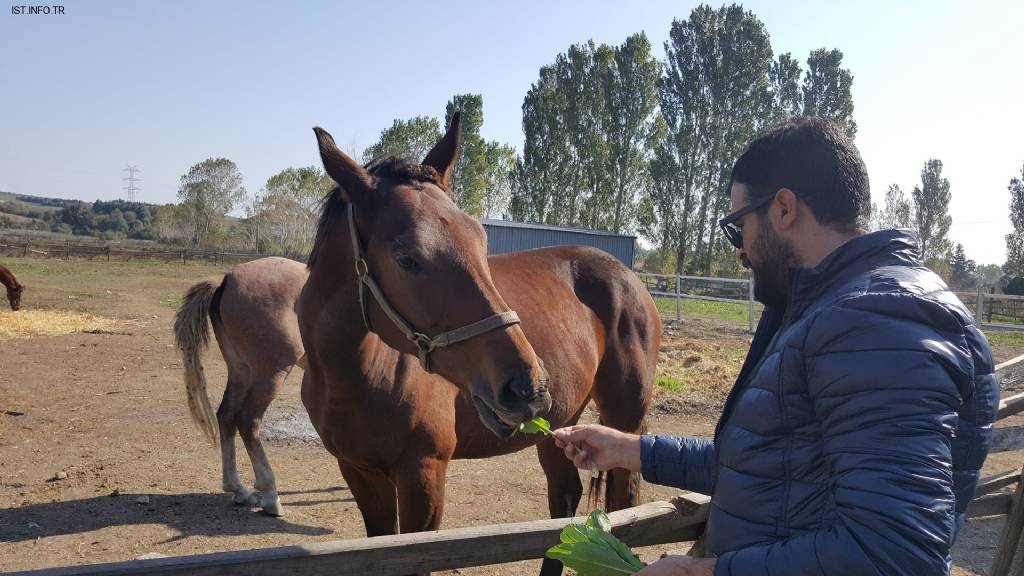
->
[555,118,998,576]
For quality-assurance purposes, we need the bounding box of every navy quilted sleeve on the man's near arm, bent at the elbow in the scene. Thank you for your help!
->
[716,294,975,576]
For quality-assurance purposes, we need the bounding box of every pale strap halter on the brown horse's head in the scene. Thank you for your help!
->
[347,202,519,372]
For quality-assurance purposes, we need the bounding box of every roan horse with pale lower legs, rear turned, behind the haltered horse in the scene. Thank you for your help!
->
[174,253,307,516]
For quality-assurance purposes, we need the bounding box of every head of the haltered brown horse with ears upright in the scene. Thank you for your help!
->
[309,116,551,437]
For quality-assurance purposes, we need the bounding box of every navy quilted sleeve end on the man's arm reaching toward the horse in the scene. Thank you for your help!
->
[640,436,715,495]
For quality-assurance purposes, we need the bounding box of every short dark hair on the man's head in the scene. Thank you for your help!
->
[730,116,871,232]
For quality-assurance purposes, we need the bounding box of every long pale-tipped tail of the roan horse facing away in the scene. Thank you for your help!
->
[174,280,224,447]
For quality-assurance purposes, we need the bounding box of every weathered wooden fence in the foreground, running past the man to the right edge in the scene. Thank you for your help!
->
[12,356,1024,576]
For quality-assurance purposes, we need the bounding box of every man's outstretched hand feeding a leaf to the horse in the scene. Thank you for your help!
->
[552,424,641,472]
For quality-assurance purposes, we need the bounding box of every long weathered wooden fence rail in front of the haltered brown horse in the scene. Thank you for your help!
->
[6,494,710,576]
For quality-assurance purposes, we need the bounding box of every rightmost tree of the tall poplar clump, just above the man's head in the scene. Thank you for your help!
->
[803,48,857,138]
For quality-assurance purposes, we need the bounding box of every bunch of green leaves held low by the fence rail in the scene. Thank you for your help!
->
[547,510,646,576]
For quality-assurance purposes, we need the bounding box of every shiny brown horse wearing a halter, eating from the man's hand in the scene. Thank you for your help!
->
[298,116,662,574]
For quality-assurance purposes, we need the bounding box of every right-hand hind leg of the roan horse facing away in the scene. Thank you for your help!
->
[238,370,288,516]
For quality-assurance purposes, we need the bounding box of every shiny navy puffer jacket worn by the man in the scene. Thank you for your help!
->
[641,231,998,576]
